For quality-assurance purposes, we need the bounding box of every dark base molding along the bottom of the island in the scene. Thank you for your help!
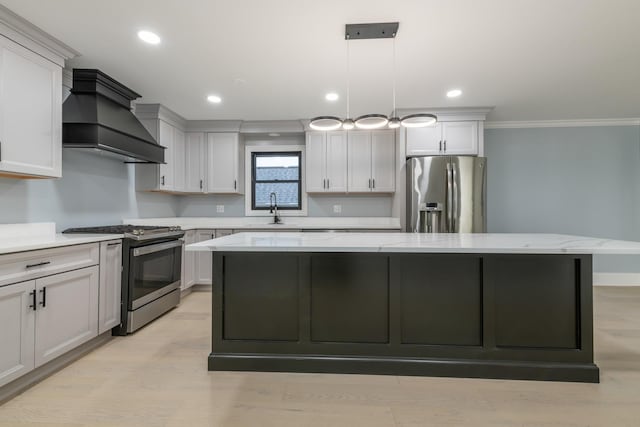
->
[208,354,600,383]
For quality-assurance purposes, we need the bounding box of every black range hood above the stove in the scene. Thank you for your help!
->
[62,68,165,163]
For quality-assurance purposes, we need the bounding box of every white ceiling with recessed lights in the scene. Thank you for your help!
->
[0,0,640,121]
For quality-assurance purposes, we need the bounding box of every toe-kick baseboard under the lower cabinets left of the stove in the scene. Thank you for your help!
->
[0,330,113,405]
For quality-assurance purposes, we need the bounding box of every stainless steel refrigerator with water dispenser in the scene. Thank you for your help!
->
[406,156,487,233]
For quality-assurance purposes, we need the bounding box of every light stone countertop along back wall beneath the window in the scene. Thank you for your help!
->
[122,216,400,231]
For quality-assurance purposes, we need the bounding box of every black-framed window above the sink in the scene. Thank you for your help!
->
[251,151,302,210]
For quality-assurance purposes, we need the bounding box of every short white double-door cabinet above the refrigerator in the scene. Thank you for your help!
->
[405,120,479,156]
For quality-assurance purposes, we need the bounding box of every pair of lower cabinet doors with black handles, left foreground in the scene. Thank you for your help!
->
[0,266,99,385]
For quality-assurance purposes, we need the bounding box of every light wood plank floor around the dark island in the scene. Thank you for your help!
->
[0,287,640,427]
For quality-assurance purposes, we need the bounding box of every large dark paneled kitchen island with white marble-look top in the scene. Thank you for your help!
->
[187,233,640,382]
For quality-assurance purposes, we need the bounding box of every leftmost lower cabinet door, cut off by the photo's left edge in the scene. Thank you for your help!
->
[0,280,35,386]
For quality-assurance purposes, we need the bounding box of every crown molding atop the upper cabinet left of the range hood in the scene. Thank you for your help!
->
[0,5,80,67]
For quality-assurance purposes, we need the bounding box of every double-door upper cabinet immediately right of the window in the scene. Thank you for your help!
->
[305,131,347,193]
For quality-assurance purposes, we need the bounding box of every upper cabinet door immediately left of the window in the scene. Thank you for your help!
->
[207,133,239,193]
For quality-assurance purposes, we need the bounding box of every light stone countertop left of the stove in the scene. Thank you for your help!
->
[0,222,124,255]
